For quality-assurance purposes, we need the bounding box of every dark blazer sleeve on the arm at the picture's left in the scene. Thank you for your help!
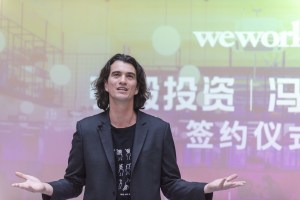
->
[42,123,85,200]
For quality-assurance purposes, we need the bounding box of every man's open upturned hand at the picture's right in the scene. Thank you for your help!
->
[204,174,246,193]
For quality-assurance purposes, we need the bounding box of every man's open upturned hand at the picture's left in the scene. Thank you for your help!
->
[12,172,53,196]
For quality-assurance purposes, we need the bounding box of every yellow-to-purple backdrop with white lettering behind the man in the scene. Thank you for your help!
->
[0,0,300,200]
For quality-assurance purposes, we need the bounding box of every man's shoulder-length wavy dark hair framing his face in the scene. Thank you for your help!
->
[92,54,150,111]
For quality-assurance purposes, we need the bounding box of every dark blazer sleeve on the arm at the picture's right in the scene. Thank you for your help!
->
[161,124,213,200]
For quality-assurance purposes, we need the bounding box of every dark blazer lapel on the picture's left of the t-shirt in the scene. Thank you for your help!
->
[98,111,116,179]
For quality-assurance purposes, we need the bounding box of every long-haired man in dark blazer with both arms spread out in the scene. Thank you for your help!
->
[13,54,245,200]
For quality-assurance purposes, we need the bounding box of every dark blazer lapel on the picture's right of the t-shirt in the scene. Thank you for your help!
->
[131,111,148,172]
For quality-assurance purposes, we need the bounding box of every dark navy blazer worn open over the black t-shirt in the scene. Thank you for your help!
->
[43,111,212,200]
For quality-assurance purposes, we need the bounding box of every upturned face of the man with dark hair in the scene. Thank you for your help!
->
[105,60,138,103]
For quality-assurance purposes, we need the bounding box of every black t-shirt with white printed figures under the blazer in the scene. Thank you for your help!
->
[111,125,135,200]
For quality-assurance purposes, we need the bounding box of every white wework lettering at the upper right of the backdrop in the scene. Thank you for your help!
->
[193,21,300,48]
